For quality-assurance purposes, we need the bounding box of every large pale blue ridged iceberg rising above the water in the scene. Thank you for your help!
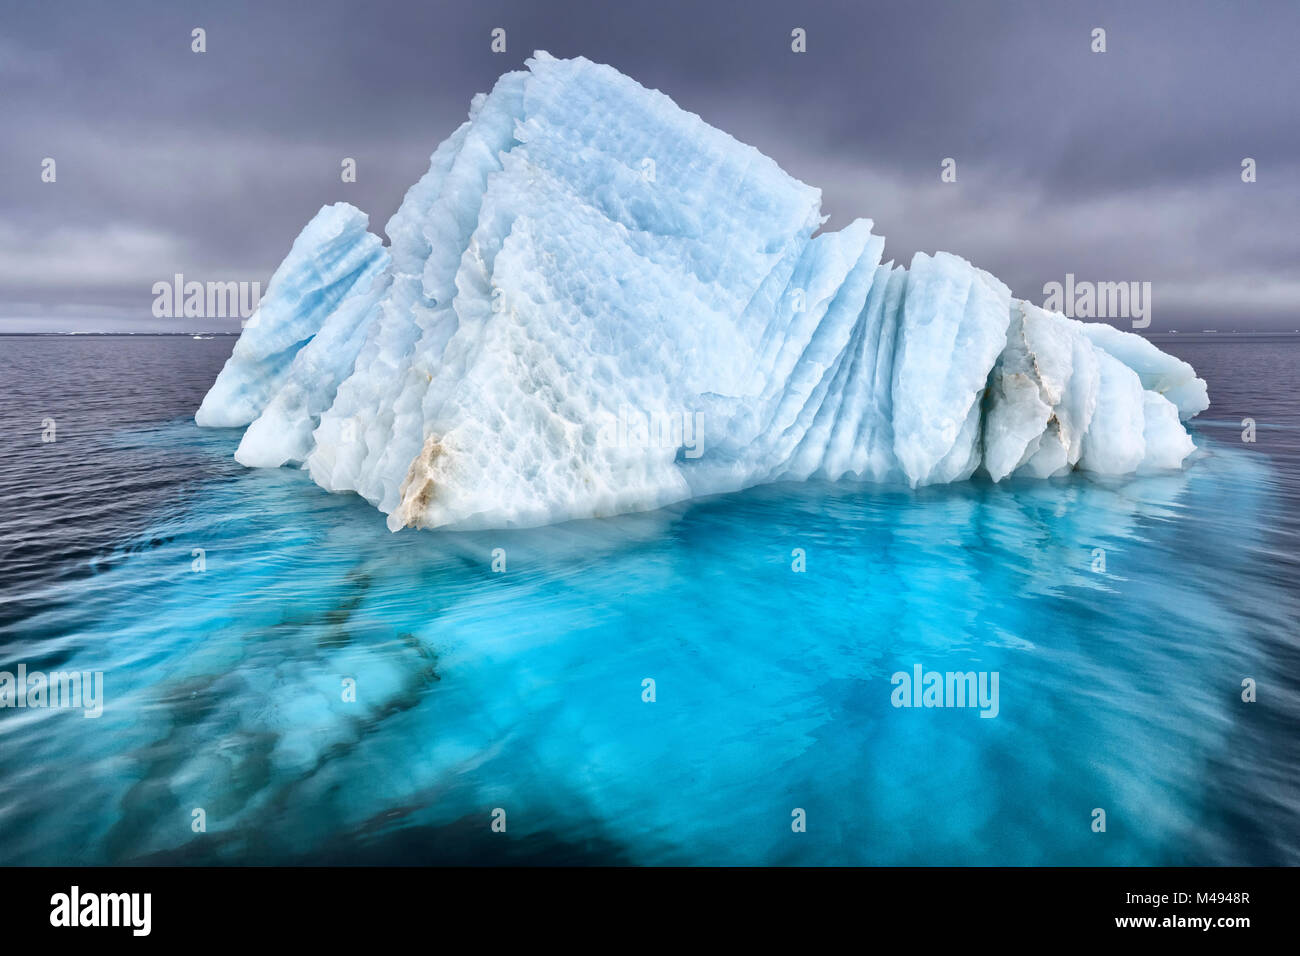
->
[195,52,1209,531]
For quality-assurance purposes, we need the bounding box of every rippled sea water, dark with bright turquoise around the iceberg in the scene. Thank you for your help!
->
[0,337,1300,864]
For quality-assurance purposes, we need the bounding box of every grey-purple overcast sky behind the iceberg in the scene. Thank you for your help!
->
[0,0,1300,332]
